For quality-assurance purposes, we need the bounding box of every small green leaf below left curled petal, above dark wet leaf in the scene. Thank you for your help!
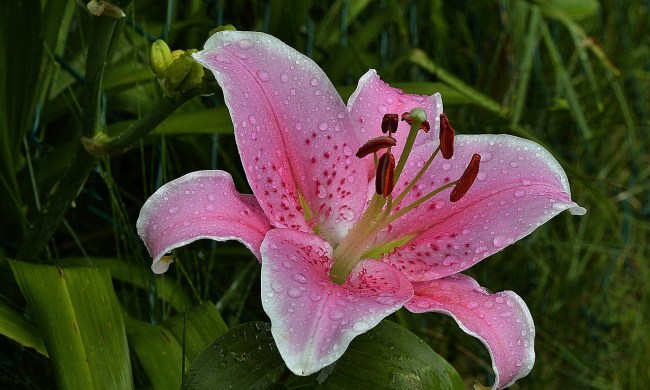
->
[163,302,228,361]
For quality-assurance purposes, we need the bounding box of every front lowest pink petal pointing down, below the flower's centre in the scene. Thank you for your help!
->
[262,229,413,375]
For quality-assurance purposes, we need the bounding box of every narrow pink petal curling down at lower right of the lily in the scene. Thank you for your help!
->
[405,274,535,389]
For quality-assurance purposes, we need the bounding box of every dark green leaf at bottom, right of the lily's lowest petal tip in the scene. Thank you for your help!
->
[323,321,465,390]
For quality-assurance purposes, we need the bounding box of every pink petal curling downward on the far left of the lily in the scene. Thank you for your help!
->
[137,171,271,274]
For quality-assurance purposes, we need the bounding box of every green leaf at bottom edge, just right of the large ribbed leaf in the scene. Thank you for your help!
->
[126,318,190,390]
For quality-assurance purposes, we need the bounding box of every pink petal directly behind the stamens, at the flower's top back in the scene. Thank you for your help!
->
[348,69,442,162]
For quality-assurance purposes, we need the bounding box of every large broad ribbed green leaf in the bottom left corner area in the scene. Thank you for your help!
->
[10,261,133,389]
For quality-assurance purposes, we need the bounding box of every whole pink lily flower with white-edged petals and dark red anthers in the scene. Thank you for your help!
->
[137,31,585,388]
